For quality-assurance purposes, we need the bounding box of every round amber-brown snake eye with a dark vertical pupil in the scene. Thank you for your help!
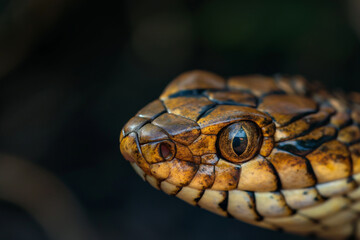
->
[218,121,261,163]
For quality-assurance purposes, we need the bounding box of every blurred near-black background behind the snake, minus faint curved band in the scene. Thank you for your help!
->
[0,0,360,240]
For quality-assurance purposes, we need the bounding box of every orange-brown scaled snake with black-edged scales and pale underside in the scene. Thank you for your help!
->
[119,70,360,239]
